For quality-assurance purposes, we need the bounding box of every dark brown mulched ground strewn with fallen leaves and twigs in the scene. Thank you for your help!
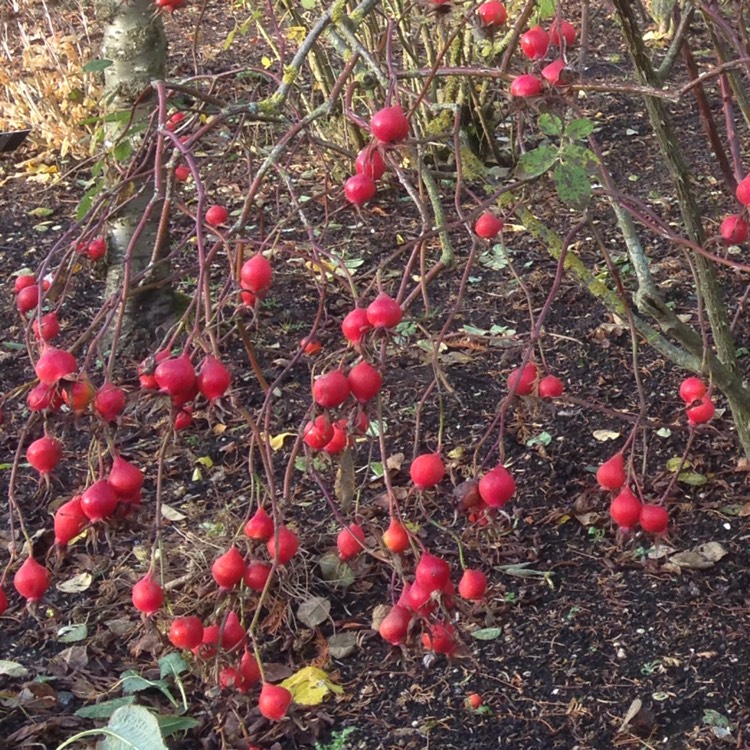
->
[0,1,750,750]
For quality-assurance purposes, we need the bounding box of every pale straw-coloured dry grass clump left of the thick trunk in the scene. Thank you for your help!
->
[0,0,101,158]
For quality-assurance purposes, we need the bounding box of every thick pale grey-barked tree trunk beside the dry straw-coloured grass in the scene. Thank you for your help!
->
[97,0,172,354]
